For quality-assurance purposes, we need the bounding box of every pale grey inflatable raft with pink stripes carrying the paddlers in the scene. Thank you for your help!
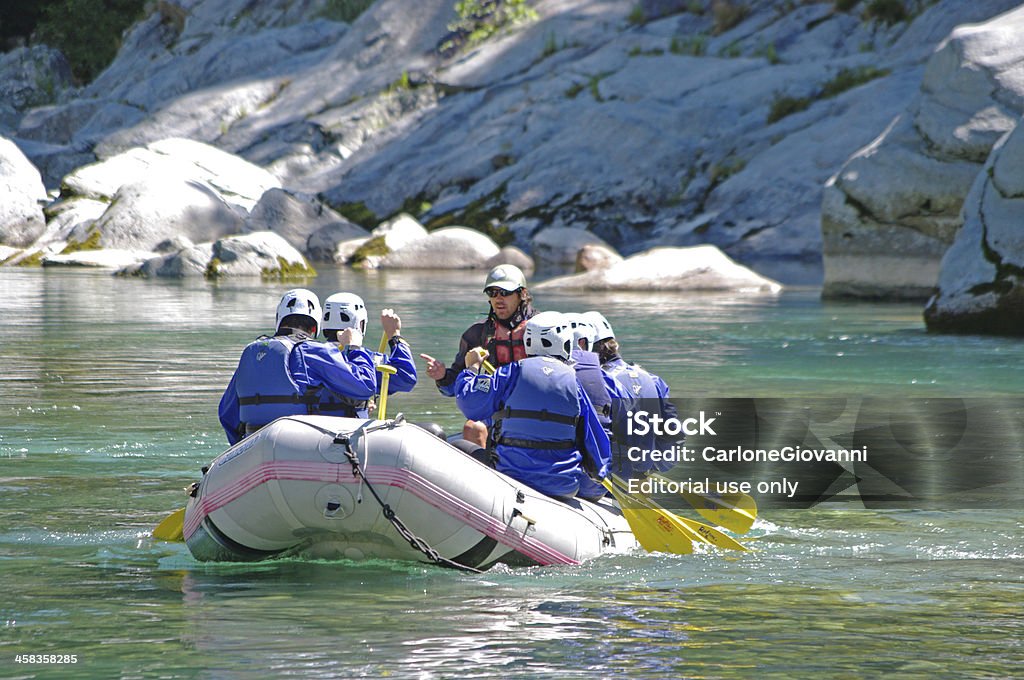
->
[184,416,637,569]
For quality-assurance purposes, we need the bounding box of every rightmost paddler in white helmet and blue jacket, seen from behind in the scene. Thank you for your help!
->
[584,311,685,478]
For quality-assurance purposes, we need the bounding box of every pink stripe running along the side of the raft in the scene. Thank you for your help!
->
[184,461,580,564]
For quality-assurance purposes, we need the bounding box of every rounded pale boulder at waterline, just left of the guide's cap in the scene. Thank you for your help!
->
[378,226,500,269]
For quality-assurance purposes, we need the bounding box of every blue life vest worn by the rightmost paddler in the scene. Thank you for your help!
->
[604,358,662,477]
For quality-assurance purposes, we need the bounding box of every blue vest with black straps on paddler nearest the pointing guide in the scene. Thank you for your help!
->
[492,356,580,451]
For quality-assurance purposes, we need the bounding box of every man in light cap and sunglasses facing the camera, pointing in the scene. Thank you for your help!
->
[420,264,537,447]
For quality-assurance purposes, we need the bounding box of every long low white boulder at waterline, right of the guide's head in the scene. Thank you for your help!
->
[534,246,782,293]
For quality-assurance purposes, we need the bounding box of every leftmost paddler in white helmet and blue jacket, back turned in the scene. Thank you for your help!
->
[218,289,377,444]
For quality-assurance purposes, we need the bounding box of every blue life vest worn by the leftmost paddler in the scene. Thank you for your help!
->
[234,335,319,429]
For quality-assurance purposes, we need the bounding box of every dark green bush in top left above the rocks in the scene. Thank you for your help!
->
[36,0,145,83]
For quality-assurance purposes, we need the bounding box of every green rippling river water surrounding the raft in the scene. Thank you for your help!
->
[0,269,1024,678]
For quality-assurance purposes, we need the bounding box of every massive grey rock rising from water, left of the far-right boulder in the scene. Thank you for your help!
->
[821,8,1024,298]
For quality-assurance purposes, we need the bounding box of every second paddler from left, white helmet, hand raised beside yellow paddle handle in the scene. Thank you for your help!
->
[318,293,417,418]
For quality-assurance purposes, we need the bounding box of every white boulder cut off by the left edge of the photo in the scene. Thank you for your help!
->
[0,137,46,248]
